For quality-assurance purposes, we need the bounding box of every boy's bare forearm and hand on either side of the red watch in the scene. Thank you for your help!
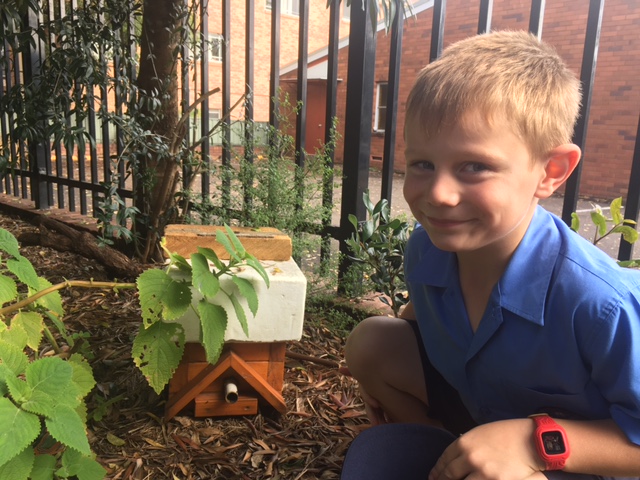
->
[429,418,640,480]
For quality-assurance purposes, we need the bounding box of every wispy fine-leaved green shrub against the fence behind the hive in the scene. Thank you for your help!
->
[180,95,338,258]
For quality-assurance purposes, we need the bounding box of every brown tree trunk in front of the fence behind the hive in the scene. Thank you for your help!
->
[135,0,183,262]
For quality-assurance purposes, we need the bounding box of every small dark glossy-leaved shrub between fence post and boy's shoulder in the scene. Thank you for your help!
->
[347,192,412,316]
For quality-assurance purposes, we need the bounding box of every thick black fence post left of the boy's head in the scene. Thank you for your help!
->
[338,1,376,278]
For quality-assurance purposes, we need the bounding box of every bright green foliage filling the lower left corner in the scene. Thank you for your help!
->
[0,229,105,480]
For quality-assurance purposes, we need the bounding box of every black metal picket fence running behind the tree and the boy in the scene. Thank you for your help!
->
[0,0,640,260]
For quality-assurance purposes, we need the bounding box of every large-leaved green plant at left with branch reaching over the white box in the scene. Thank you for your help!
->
[0,223,269,480]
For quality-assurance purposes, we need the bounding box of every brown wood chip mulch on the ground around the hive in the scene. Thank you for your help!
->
[0,214,380,480]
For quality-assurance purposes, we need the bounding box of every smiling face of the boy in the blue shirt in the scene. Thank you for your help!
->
[404,113,545,255]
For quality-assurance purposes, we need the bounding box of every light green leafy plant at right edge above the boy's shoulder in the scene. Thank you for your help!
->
[571,197,640,268]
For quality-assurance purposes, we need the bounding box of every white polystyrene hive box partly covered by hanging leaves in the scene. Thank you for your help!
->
[169,259,307,342]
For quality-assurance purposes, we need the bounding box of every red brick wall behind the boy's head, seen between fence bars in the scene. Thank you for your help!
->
[336,0,640,199]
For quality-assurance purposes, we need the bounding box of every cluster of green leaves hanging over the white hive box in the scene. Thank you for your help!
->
[132,226,269,393]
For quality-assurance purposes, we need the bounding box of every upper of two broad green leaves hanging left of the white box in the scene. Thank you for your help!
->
[137,269,191,328]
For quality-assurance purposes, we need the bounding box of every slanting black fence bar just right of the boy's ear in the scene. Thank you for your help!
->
[562,0,604,225]
